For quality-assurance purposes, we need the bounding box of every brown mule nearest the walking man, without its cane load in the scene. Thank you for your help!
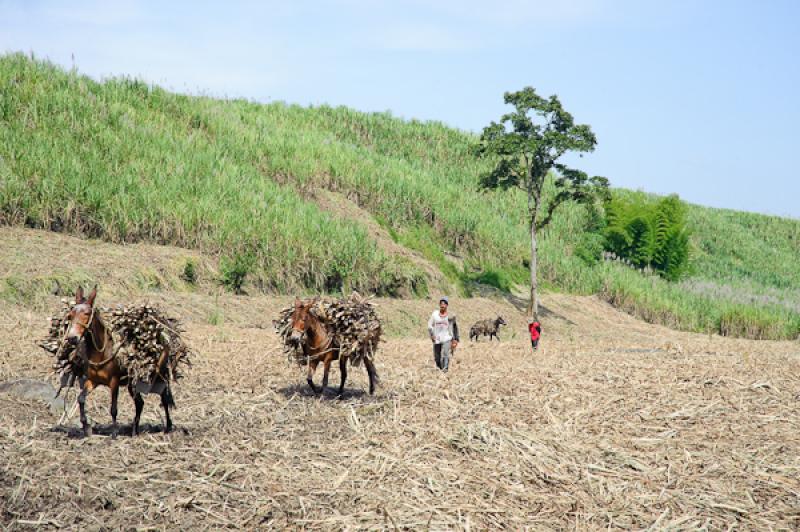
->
[289,298,378,395]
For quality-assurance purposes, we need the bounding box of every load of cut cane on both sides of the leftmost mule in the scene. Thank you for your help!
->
[39,300,192,386]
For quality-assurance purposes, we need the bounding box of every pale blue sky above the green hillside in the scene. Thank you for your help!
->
[0,0,800,218]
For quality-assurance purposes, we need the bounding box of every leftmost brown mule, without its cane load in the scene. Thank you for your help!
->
[66,286,175,438]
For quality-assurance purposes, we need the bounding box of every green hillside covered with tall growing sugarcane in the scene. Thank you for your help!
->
[0,54,800,338]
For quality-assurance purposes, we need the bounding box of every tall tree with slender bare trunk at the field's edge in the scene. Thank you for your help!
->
[477,87,608,317]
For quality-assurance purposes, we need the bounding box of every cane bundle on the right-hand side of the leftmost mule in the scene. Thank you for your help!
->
[104,305,192,385]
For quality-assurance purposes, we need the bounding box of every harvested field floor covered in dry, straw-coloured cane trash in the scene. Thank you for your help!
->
[0,229,800,530]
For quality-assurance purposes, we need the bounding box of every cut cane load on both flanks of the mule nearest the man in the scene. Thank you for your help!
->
[273,292,383,366]
